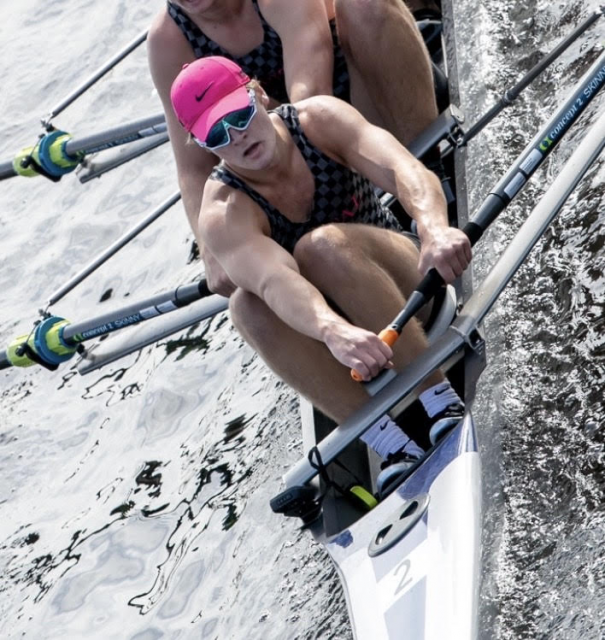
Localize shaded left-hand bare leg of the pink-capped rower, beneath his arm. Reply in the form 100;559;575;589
229;289;368;423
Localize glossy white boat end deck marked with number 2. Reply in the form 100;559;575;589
315;414;481;640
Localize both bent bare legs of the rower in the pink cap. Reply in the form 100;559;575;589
229;224;444;422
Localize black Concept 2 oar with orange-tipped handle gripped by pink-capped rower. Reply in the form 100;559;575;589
351;53;605;381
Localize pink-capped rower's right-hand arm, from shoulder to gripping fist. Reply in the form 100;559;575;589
299;96;471;282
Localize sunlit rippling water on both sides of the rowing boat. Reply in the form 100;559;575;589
0;0;605;640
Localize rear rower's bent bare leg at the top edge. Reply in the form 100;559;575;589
335;0;437;144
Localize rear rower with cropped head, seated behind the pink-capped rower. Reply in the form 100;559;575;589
148;0;437;296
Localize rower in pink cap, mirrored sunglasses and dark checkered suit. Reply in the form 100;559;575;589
171;57;471;496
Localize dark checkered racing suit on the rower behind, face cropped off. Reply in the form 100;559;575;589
168;0;349;102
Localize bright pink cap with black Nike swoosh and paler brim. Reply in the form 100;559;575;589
170;56;250;141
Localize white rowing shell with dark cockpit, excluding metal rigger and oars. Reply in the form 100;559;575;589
290;3;484;640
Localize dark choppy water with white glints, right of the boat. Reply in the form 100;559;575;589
462;2;605;640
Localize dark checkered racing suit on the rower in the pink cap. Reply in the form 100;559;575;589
209;104;407;253
